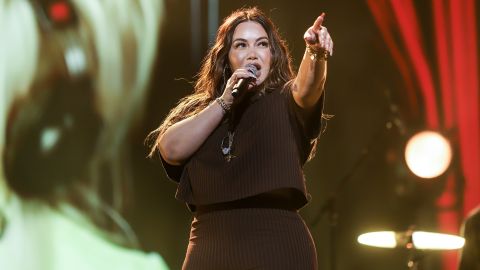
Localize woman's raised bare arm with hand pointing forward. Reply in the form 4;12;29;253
293;13;333;111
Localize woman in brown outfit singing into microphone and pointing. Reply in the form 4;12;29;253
151;8;333;270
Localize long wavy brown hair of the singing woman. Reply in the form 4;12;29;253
147;7;295;156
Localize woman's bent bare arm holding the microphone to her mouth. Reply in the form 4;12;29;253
158;68;252;165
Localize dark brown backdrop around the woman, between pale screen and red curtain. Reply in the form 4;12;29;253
127;0;456;270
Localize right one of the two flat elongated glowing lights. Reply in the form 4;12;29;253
412;231;465;250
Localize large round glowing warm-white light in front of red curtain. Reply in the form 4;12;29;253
405;131;452;178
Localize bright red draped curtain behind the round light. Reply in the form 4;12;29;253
367;0;480;270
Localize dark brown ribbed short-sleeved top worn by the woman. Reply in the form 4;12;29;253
162;86;323;209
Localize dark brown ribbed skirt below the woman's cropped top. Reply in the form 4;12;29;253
182;208;318;270
